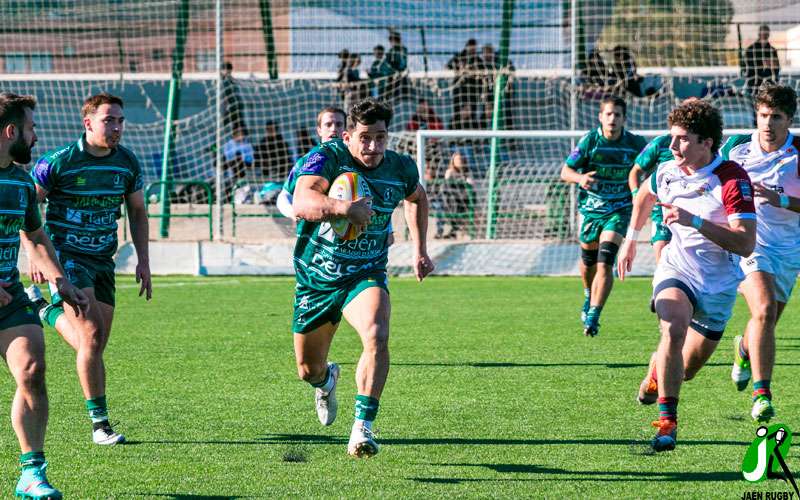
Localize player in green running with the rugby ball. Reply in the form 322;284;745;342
292;98;433;457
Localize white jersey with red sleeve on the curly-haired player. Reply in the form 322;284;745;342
650;156;756;294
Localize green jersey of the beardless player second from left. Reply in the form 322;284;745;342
31;136;143;257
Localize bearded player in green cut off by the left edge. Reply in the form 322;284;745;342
0;92;89;499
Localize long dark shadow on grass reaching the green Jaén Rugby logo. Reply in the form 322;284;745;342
407;462;742;484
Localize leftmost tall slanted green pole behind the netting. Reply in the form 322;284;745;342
160;0;189;238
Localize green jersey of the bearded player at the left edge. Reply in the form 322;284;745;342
0;163;42;284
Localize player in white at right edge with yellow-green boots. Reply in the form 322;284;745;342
720;84;800;422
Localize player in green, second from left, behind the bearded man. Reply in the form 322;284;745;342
23;93;152;445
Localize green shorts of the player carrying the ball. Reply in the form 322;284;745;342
292;272;389;333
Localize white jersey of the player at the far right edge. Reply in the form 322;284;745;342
728;132;800;256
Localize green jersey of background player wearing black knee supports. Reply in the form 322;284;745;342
565;127;647;216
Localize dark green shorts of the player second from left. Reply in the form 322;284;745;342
50;252;117;307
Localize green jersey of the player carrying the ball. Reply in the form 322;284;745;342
294;140;419;290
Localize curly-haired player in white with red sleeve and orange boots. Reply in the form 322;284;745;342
618;99;756;451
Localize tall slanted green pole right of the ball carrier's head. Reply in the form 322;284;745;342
486;0;514;240
